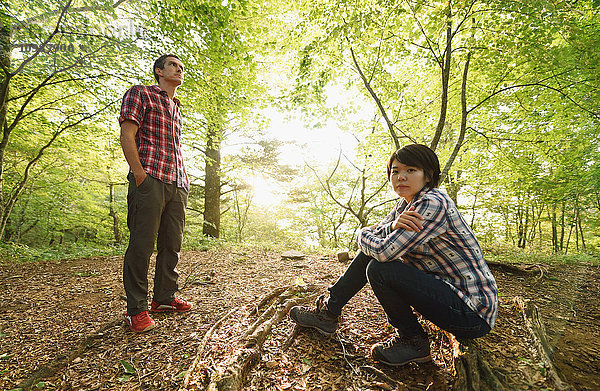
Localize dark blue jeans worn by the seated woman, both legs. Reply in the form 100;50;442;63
327;252;490;339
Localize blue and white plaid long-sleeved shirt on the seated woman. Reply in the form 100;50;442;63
358;188;498;328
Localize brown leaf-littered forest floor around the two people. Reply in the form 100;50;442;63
0;249;600;390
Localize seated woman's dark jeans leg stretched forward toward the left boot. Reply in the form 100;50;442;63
327;252;371;316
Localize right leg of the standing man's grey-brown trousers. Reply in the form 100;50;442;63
154;184;188;304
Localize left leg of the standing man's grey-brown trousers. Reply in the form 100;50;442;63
123;173;163;315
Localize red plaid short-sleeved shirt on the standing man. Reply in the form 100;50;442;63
119;85;189;189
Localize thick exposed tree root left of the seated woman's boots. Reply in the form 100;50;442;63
180;285;319;391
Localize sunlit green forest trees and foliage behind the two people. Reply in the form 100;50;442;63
0;0;600;254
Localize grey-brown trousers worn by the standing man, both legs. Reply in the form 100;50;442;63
123;173;187;315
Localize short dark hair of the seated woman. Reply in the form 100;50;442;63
387;144;440;187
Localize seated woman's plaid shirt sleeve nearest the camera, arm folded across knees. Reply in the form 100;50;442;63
357;198;447;262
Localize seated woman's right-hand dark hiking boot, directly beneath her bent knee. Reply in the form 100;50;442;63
371;335;431;366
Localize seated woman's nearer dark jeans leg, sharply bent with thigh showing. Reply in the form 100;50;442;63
367;260;490;339
